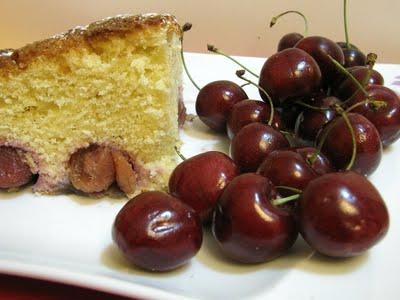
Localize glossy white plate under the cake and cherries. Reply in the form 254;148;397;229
0;54;400;300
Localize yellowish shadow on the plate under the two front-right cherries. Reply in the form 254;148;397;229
196;231;368;275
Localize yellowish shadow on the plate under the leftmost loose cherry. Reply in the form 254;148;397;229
100;244;190;278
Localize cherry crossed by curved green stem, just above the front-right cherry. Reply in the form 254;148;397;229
319;113;382;176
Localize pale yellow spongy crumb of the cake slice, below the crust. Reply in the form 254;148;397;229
0;18;182;193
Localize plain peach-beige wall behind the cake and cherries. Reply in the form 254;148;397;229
0;0;400;63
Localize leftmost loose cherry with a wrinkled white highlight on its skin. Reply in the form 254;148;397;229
112;192;203;271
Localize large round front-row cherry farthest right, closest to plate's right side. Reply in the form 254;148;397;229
298;172;389;257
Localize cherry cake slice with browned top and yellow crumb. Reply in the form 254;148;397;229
0;14;184;196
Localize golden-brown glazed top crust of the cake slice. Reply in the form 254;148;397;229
0;14;182;75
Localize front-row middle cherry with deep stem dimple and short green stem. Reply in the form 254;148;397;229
212;173;298;263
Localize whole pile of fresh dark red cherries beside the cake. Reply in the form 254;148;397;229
113;1;400;271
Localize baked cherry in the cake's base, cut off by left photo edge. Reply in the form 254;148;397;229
0;146;33;189
